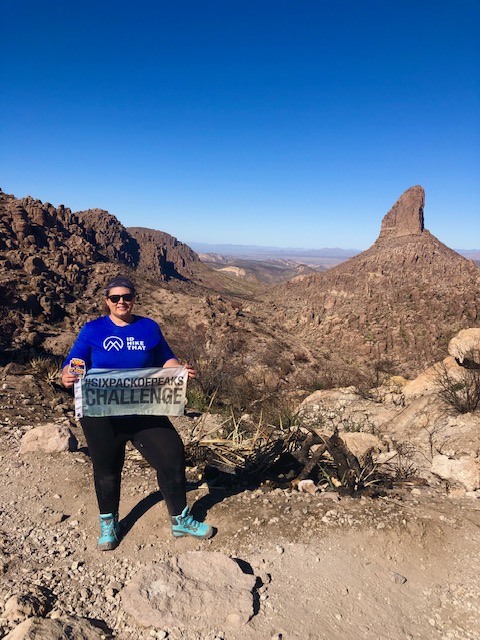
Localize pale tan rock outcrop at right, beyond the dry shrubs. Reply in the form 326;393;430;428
298;329;480;492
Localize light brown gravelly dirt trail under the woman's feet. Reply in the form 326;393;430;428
0;418;480;640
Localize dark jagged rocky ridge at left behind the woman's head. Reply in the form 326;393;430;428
0;191;221;362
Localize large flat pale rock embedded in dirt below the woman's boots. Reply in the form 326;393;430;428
121;551;256;629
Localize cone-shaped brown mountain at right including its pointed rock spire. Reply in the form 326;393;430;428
267;186;480;375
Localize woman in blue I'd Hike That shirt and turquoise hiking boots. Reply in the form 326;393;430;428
62;276;214;551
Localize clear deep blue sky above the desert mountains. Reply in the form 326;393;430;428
0;0;480;249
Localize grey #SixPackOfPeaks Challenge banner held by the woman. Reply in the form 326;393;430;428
75;367;188;418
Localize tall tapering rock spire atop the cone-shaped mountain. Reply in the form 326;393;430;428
379;185;425;245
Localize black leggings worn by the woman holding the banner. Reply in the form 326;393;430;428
80;416;187;516
